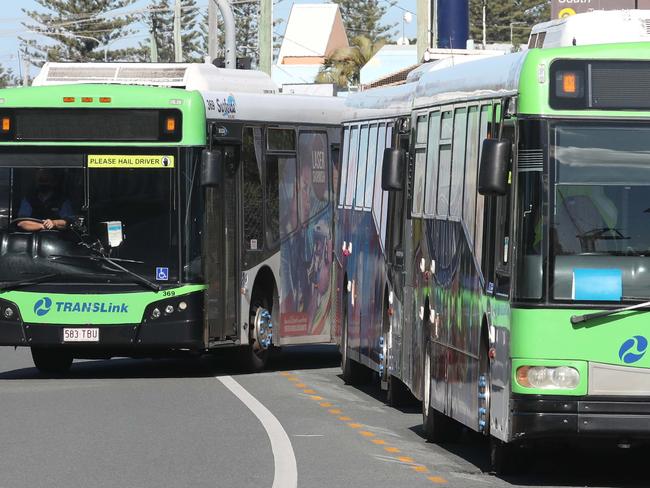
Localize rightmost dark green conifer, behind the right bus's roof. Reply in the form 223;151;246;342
469;0;551;45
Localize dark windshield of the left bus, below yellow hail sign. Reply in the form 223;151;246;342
0;150;179;284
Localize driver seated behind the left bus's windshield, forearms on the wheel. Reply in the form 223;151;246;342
17;169;73;232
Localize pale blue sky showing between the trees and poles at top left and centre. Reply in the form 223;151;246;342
0;0;417;74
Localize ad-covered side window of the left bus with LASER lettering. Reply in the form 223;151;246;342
298;132;329;223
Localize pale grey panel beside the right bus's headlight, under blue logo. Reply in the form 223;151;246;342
588;363;650;396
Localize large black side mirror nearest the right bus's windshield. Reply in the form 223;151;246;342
478;139;510;196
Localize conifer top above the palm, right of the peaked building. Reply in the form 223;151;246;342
334;0;397;44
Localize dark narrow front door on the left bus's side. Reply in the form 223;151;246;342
203;143;240;343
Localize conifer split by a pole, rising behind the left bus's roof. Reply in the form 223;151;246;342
139;0;203;63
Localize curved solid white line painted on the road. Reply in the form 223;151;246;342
217;376;298;488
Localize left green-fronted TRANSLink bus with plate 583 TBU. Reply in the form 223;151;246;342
0;64;342;372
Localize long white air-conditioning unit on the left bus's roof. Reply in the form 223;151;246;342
32;63;278;93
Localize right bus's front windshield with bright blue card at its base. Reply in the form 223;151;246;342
550;123;650;301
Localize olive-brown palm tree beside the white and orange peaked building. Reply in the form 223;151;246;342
316;36;385;88
